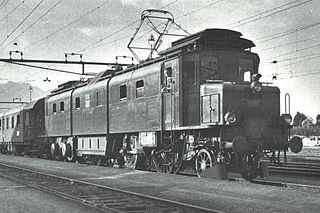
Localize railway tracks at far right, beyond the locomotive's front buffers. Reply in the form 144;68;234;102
268;162;320;177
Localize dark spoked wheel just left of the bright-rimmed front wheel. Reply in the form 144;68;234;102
152;151;175;174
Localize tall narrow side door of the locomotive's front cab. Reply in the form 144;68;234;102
161;59;179;130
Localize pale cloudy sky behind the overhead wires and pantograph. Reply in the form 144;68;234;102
0;0;320;118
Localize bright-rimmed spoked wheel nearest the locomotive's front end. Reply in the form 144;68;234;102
195;149;216;177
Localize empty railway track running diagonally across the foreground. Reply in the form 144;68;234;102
0;163;221;213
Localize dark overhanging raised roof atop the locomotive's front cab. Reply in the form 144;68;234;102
160;29;255;55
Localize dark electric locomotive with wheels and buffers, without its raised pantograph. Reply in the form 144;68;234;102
0;29;302;179
